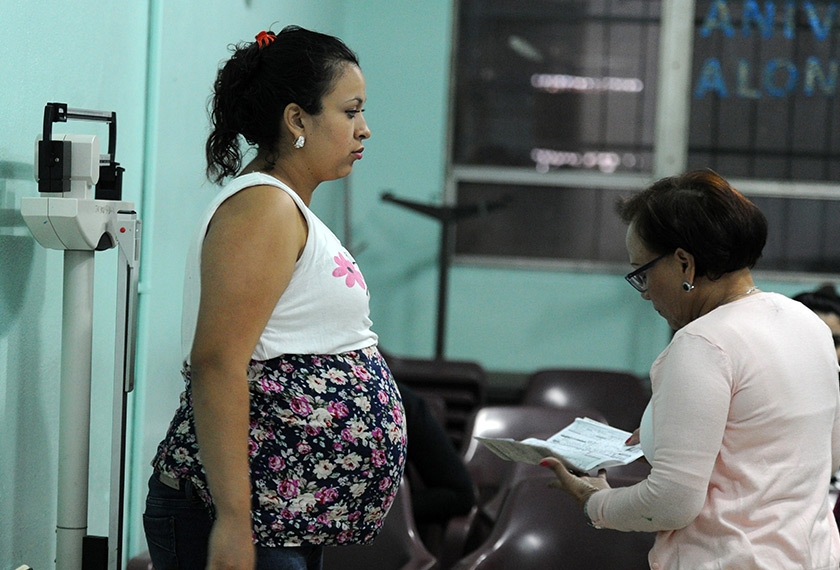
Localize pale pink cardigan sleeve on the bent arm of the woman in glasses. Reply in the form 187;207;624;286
587;333;732;531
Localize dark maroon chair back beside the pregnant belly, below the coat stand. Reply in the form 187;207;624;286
385;354;487;449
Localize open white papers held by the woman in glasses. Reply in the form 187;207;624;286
475;418;643;474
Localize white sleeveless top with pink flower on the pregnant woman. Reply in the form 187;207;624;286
181;172;378;362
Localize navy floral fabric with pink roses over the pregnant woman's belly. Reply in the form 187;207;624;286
152;346;406;546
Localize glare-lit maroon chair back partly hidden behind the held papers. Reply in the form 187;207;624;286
463;406;605;505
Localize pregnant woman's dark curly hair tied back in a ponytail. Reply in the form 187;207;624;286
205;26;359;183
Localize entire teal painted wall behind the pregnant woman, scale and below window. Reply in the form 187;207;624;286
0;0;828;560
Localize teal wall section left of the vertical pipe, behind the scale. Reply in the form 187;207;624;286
0;0;147;568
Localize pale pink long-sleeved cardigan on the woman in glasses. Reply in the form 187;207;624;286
587;293;840;570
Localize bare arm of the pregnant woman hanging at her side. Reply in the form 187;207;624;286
190;186;306;570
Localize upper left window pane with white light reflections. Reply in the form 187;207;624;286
452;0;660;173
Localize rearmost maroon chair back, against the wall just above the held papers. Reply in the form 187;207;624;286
522;368;650;432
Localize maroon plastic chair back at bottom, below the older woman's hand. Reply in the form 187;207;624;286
453;476;655;570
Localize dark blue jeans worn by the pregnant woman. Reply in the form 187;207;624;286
143;474;324;570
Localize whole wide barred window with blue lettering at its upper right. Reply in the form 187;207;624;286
447;0;840;274
